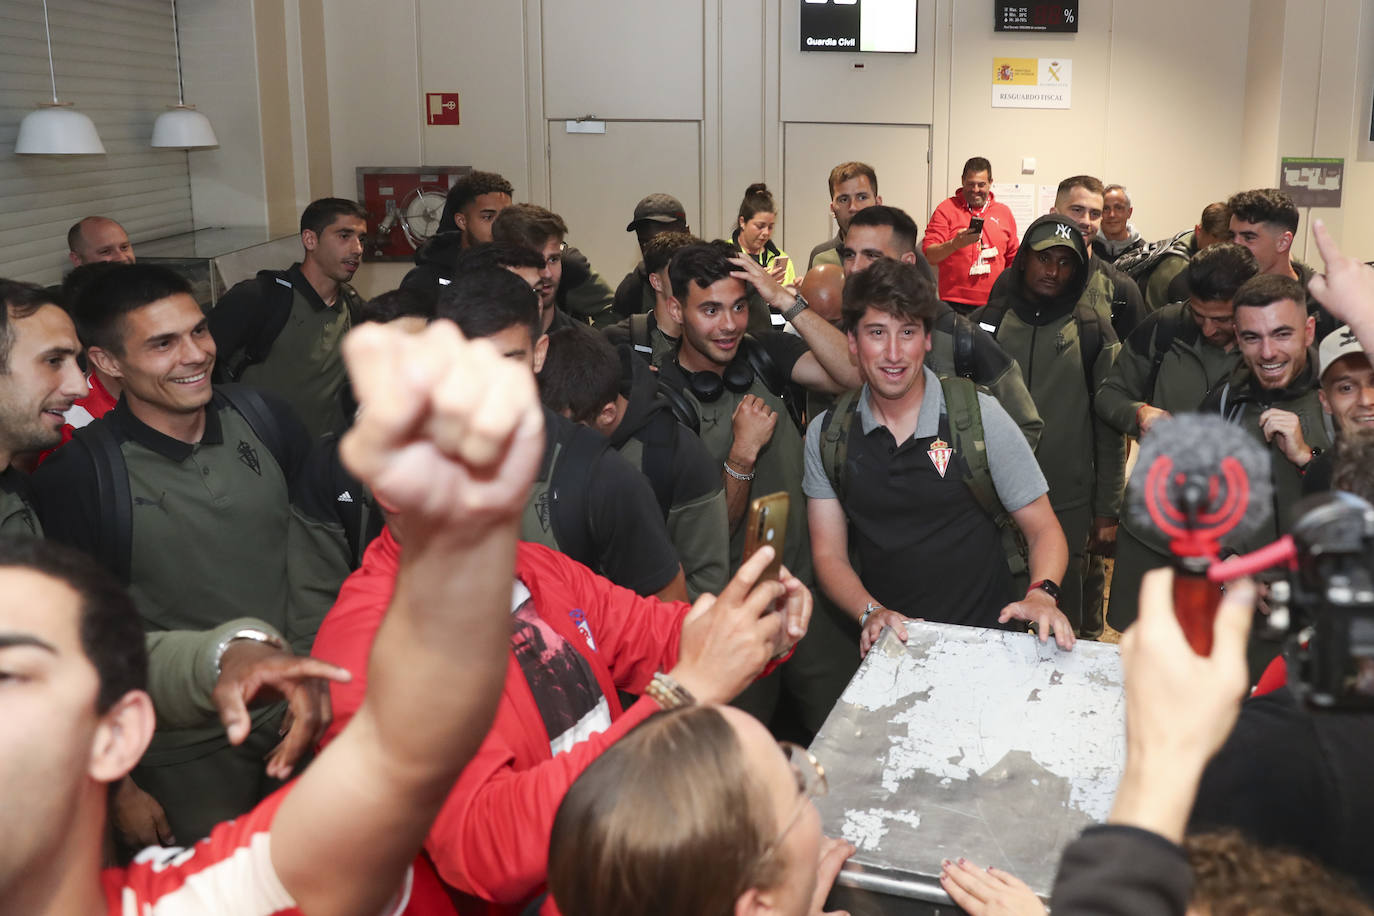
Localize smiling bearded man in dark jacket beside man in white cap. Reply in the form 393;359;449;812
1201;273;1331;548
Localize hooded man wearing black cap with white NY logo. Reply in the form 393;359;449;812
974;214;1125;629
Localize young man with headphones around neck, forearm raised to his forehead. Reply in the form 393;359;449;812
660;243;860;732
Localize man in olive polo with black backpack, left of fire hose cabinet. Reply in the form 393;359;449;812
209;198;367;438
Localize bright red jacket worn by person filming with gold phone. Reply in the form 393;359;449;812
313;531;690;913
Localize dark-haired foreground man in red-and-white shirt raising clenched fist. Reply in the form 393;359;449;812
0;311;563;916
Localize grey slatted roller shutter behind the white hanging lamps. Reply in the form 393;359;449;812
0;0;192;283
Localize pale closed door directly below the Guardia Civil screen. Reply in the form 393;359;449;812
782;121;944;265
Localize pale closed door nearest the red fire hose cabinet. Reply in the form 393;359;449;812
548;121;709;281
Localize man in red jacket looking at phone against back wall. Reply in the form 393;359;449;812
921;157;1021;314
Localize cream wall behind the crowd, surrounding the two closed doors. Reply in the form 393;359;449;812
185;0;1374;298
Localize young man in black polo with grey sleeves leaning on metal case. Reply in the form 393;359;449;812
802;260;1074;652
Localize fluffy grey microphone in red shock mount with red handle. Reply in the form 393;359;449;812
1127;413;1274;655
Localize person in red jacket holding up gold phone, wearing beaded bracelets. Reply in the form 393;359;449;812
313;518;811;913
